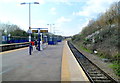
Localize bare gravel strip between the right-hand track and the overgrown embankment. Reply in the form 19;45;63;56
74;45;120;82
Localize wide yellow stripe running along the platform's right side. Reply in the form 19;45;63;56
61;42;71;83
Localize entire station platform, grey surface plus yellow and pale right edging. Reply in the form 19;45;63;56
0;41;89;83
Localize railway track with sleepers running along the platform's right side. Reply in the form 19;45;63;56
68;41;117;83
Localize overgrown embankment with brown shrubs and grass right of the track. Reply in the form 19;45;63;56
72;2;120;77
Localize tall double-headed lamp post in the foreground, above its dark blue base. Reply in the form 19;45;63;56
21;2;39;42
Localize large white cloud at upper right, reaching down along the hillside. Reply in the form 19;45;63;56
72;0;118;31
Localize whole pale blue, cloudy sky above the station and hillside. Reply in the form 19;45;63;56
0;0;119;36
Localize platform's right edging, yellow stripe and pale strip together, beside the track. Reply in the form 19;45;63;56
61;41;89;83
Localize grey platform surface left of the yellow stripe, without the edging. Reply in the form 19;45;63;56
1;42;63;81
